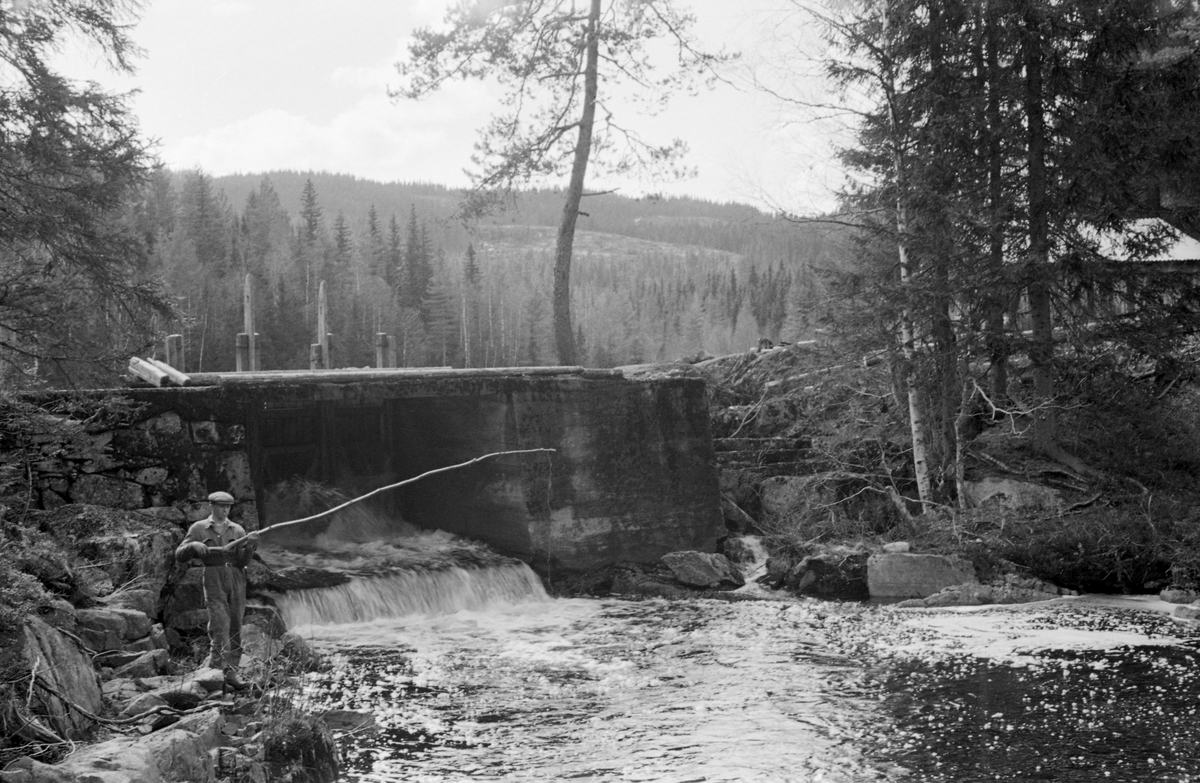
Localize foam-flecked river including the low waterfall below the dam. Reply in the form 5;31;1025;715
270;547;1200;783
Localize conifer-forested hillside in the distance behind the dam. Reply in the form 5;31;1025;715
134;171;845;371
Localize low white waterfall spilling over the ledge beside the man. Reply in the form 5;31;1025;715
278;563;550;628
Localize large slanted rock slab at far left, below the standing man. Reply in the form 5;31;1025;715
18;617;102;740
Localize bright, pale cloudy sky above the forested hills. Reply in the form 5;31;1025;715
56;0;840;213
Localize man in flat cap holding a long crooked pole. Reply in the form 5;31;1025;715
175;492;258;691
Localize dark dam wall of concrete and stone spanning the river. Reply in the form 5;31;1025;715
18;367;725;574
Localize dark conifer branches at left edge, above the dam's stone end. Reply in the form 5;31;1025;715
0;0;168;385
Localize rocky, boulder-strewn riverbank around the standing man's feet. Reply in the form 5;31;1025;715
0;506;337;783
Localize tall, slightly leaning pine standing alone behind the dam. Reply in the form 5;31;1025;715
392;0;728;364
